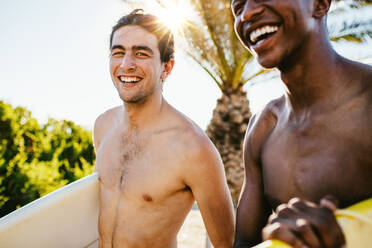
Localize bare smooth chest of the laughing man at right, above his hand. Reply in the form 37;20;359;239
261;109;372;206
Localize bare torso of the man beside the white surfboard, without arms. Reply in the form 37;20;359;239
96;109;194;247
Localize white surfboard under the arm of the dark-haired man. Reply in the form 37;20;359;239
0;173;99;248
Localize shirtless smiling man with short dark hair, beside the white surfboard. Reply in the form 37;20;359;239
94;10;234;248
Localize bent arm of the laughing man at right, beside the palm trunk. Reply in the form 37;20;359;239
234;111;275;247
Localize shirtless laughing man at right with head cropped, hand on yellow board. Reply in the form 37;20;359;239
231;0;372;247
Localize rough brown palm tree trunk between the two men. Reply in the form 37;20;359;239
206;85;251;204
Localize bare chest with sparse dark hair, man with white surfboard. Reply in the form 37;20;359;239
96;130;185;204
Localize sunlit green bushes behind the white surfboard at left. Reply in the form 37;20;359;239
0;101;95;216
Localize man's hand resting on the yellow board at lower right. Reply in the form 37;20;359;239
262;197;345;248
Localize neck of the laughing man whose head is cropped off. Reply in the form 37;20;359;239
279;31;344;115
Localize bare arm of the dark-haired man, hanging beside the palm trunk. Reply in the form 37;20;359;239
185;137;234;248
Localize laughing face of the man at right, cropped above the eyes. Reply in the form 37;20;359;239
231;0;314;68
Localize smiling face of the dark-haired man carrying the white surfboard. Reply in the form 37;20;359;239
110;25;163;103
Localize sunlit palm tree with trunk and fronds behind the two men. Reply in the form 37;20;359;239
124;0;372;203
